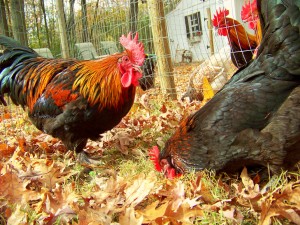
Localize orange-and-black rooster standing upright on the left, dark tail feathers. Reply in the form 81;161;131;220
0;33;145;163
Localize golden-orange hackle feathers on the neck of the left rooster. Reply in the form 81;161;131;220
70;53;135;109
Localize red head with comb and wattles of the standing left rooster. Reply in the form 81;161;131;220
118;33;145;87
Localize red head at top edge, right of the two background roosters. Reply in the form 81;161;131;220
241;0;259;30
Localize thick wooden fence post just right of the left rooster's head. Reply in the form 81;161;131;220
147;0;177;100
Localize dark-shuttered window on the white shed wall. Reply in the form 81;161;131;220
185;12;202;41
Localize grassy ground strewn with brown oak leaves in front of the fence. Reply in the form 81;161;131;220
0;63;300;225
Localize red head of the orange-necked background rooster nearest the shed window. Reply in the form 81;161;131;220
212;9;231;36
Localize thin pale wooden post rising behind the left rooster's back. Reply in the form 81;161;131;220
56;0;70;58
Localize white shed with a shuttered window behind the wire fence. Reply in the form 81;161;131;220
166;0;251;62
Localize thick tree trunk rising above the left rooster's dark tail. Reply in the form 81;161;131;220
10;0;28;46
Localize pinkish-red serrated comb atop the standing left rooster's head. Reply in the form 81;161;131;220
120;32;145;66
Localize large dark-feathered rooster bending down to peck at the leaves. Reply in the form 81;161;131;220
149;1;300;178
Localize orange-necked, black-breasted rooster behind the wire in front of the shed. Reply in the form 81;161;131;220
212;9;258;68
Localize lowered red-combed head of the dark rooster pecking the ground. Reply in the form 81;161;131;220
149;146;184;179
